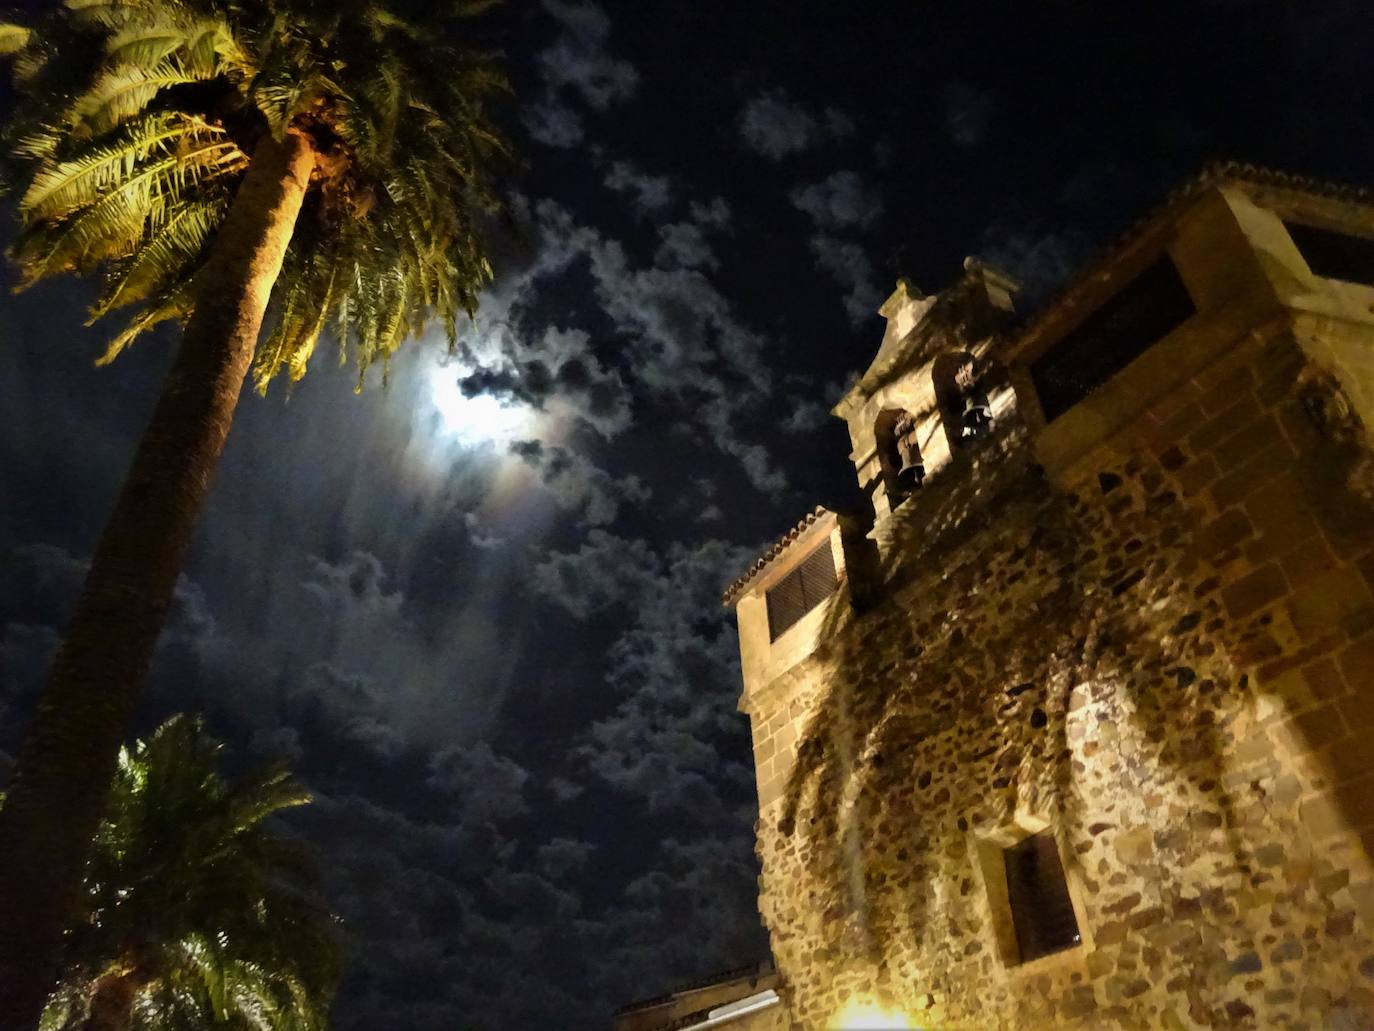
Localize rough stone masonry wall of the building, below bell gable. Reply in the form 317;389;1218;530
746;305;1374;1031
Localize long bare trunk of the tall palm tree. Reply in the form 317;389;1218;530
0;133;315;1031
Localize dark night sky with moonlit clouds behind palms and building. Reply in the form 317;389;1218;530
0;0;1374;1031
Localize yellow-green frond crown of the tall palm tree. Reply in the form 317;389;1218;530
0;0;504;390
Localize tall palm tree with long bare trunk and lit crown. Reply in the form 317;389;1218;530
0;0;503;1031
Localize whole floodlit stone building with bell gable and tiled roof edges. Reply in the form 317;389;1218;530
725;166;1374;1031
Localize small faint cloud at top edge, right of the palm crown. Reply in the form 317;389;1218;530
525;0;639;147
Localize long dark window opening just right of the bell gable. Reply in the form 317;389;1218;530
1031;254;1197;419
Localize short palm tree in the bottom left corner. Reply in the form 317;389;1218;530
30;716;338;1031
